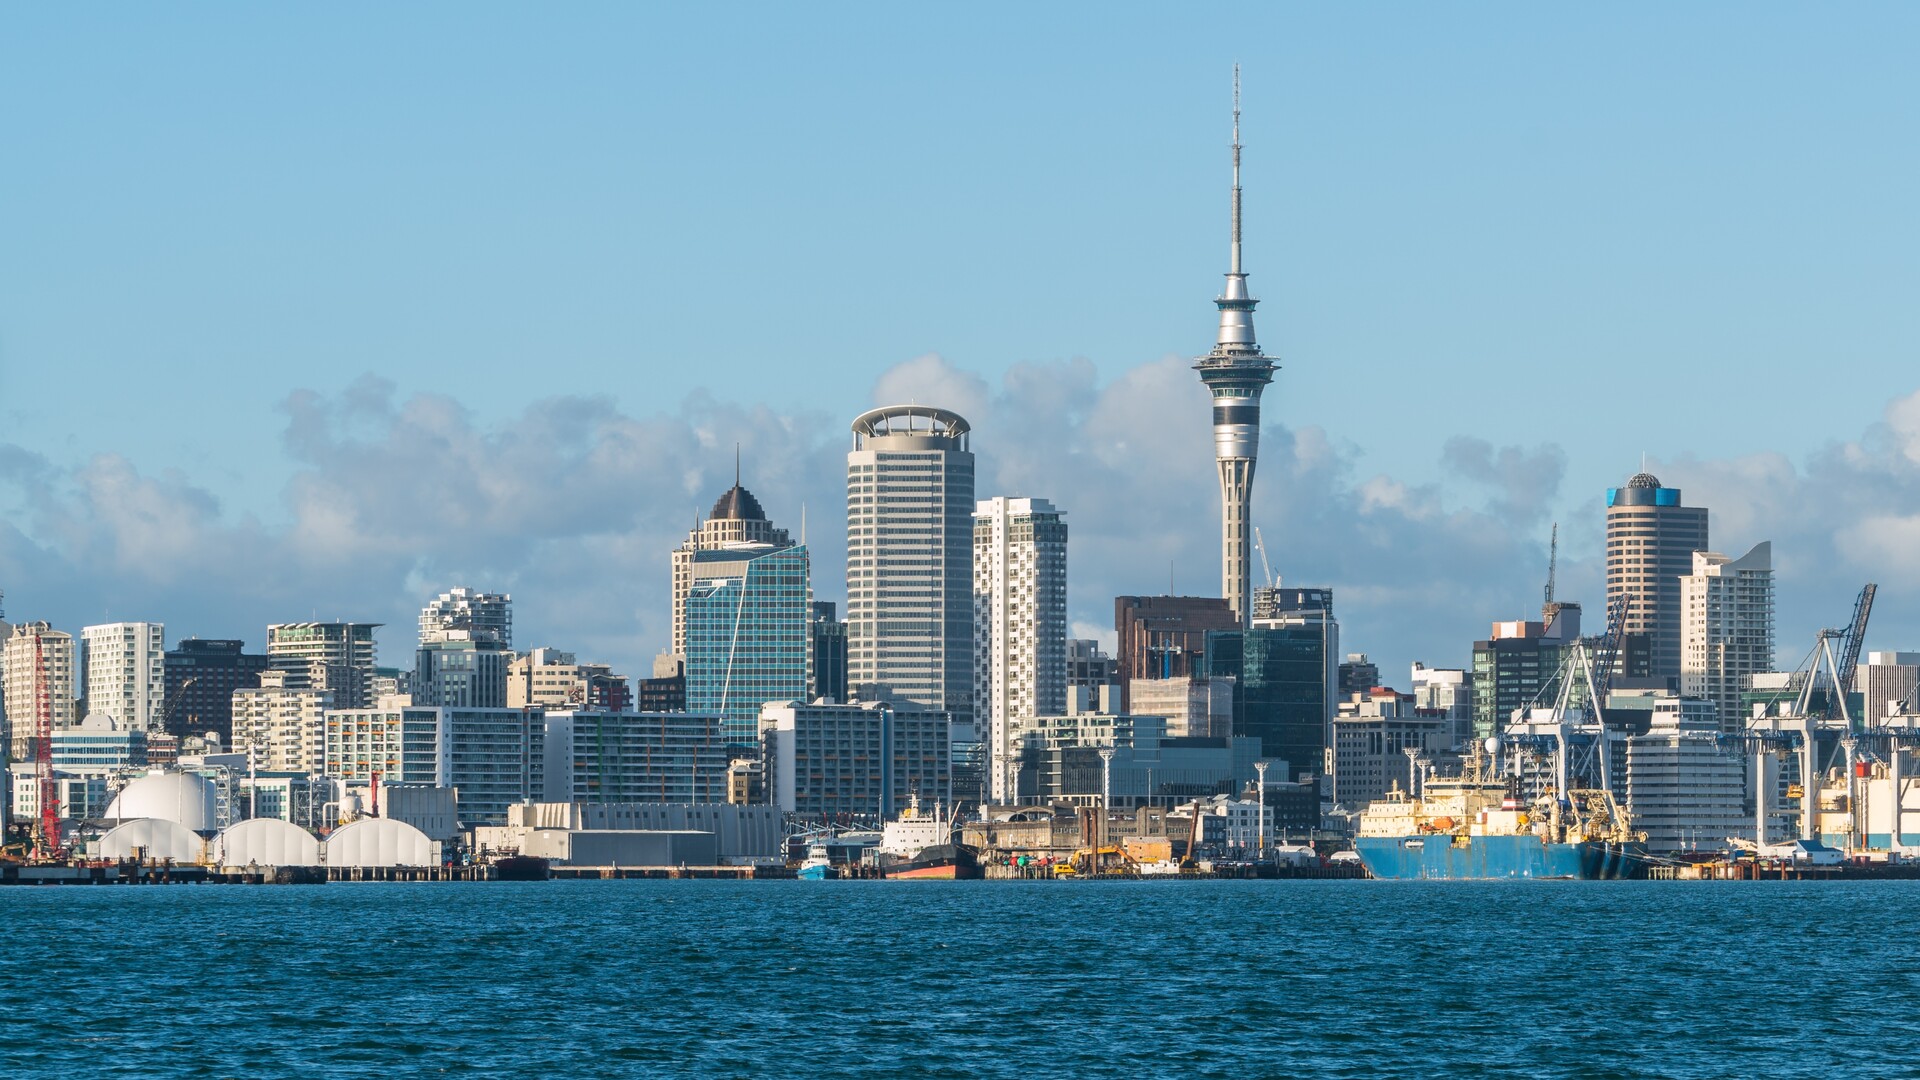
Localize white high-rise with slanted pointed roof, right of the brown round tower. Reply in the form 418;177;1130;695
1680;540;1774;732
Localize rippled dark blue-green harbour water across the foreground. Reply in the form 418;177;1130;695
0;880;1920;1080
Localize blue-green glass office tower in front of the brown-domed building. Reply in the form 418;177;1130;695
687;544;814;748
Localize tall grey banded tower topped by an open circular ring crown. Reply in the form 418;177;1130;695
847;405;973;726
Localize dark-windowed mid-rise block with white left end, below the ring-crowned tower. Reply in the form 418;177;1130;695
760;701;952;821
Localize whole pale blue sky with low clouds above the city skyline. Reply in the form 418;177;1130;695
0;4;1920;684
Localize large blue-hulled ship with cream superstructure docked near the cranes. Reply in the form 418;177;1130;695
1354;748;1647;880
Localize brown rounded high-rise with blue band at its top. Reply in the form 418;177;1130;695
1607;473;1707;680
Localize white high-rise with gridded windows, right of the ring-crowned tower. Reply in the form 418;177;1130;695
973;498;1068;803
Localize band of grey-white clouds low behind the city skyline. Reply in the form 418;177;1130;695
0;356;1920;682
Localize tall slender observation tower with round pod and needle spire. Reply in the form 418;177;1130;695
1194;63;1279;626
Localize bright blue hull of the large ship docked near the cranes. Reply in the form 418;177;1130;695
1354;834;1647;880
